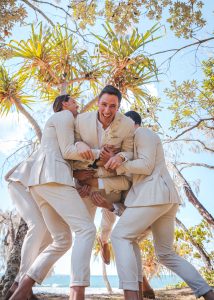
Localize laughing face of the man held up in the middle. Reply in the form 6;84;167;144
98;93;119;129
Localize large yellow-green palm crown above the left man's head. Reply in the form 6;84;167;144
9;23;102;95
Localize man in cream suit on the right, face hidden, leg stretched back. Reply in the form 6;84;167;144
109;111;214;300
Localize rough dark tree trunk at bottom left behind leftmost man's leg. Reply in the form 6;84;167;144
0;219;27;296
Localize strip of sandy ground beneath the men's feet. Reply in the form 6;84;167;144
37;288;203;300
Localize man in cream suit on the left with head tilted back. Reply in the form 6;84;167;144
11;95;96;300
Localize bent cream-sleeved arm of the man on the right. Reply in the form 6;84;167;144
117;129;158;175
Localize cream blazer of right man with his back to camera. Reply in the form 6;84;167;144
117;128;181;207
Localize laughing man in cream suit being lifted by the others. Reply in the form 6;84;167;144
73;85;134;263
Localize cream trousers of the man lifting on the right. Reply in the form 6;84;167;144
111;204;211;297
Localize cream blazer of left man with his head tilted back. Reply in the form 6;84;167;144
28;110;87;186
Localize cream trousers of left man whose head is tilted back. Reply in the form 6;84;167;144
27;183;96;286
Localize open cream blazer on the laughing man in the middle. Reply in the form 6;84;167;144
74;111;134;172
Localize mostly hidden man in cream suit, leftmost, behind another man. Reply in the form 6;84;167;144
4;153;52;300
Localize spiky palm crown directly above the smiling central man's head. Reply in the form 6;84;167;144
82;23;160;109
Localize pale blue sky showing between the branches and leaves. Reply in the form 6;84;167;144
0;0;214;274
